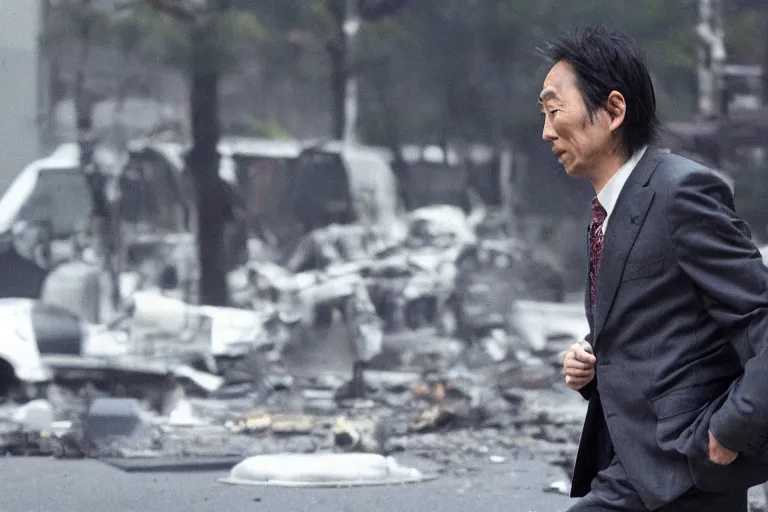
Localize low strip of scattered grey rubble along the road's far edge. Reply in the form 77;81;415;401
0;352;585;474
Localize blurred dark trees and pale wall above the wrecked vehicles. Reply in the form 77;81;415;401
0;0;768;299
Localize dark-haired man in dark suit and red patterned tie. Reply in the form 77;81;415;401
539;28;768;512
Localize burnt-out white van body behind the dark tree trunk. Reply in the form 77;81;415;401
122;137;402;268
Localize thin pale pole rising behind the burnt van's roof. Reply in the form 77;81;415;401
343;0;362;146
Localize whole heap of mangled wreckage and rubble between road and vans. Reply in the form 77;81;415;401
0;195;586;484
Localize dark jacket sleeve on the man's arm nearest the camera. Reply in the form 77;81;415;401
667;171;768;453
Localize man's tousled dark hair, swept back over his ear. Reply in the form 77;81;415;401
542;27;659;156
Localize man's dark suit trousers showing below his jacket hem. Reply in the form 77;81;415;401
568;456;748;512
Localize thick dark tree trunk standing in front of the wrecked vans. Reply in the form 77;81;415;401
146;0;260;305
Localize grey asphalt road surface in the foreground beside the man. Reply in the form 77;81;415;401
0;457;571;512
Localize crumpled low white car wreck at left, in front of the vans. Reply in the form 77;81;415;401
0;291;298;408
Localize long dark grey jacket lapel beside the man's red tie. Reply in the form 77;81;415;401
593;149;662;343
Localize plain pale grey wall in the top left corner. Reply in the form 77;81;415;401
0;0;41;194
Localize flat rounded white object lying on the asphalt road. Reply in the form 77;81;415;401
220;453;434;487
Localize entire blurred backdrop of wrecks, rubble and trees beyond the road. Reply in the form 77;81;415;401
0;0;768;492
